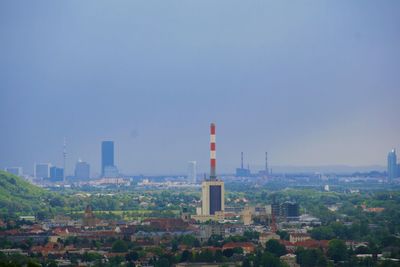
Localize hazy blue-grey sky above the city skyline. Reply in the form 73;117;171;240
0;0;400;174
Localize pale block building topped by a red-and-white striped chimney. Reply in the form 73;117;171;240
201;123;225;216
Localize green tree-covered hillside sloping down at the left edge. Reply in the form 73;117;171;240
0;171;59;216
